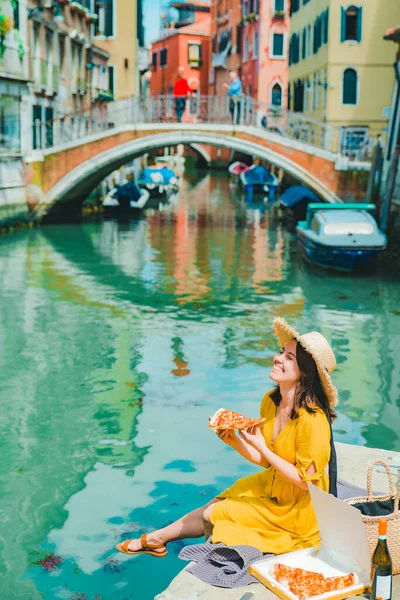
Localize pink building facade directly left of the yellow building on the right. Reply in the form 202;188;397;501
240;0;289;108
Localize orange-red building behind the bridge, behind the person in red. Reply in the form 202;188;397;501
150;2;211;95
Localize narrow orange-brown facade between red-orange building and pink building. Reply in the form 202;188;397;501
209;0;242;96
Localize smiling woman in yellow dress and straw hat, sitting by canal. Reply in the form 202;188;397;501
117;318;337;557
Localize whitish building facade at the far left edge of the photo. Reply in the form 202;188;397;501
0;0;29;222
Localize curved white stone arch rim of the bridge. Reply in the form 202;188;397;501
38;129;338;216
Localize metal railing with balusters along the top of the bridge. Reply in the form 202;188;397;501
34;95;374;161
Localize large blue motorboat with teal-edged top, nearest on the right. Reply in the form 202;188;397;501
296;203;387;272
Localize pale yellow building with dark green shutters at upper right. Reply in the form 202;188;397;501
289;0;400;147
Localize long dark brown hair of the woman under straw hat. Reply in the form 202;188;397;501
271;343;336;423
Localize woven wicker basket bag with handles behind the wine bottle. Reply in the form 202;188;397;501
344;459;400;575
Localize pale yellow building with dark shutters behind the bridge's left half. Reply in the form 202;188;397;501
95;0;143;100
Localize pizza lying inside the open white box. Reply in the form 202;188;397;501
274;563;358;600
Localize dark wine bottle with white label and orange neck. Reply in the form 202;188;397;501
370;519;393;600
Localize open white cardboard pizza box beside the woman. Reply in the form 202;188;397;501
249;484;371;600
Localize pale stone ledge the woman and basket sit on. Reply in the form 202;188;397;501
155;443;400;600
